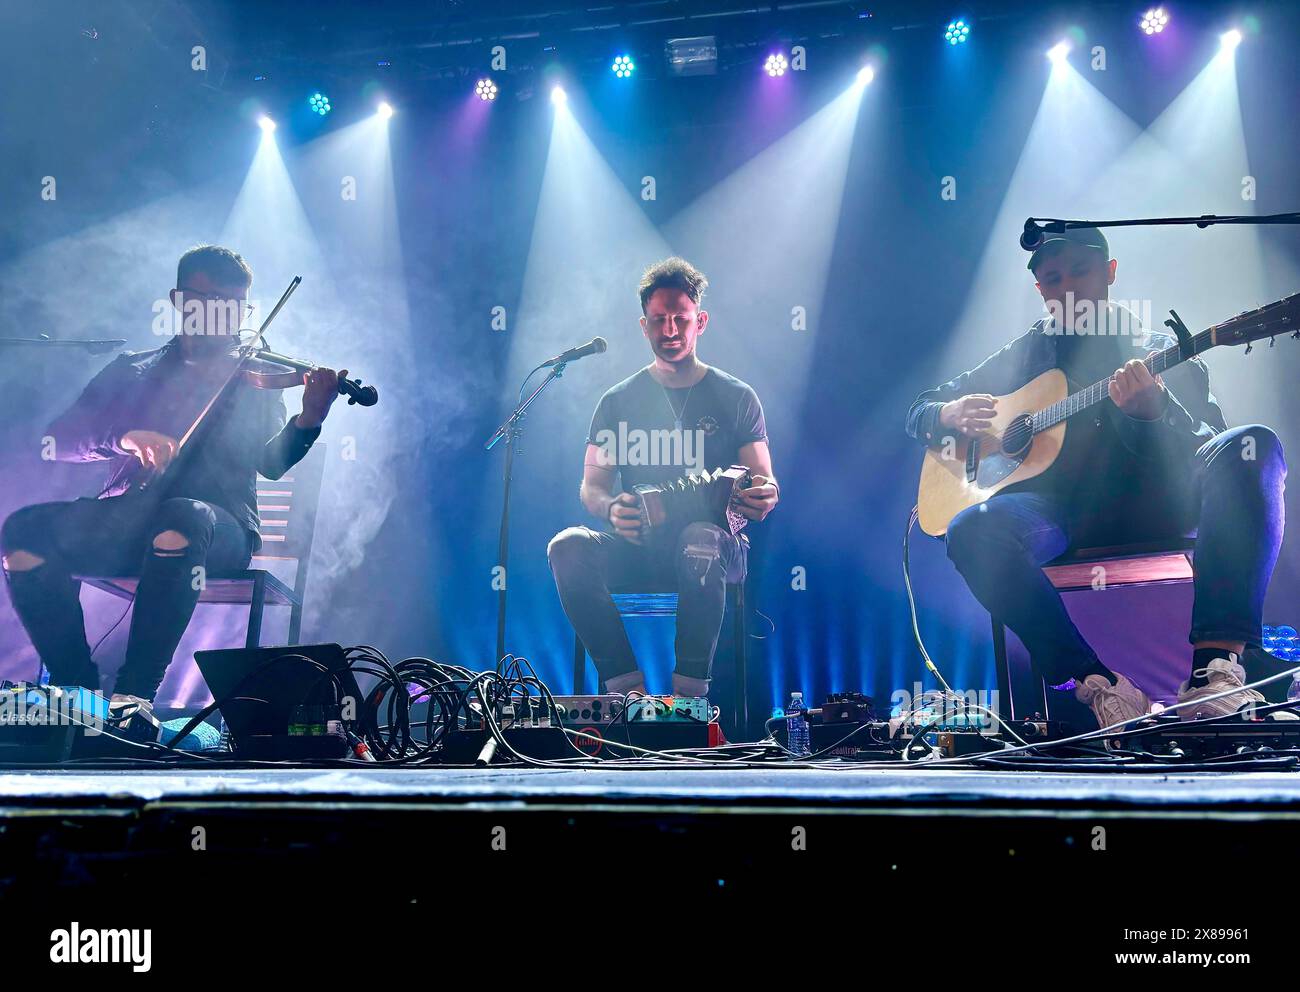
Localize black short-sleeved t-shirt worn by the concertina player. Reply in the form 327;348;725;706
586;367;767;491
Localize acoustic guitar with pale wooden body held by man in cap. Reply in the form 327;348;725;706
917;293;1300;537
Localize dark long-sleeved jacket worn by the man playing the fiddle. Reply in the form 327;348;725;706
47;341;320;545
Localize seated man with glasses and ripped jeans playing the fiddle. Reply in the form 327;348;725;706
0;244;347;709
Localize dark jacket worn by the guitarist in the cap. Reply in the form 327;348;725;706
906;308;1227;527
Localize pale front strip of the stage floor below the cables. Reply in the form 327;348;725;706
0;766;1300;816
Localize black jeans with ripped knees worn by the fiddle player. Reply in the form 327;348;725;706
0;497;255;699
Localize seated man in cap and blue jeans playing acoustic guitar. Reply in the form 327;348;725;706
907;228;1291;727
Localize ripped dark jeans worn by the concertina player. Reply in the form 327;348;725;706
546;523;748;681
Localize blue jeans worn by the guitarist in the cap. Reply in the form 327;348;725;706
948;425;1287;685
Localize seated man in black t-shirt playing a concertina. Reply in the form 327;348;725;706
546;257;780;696
